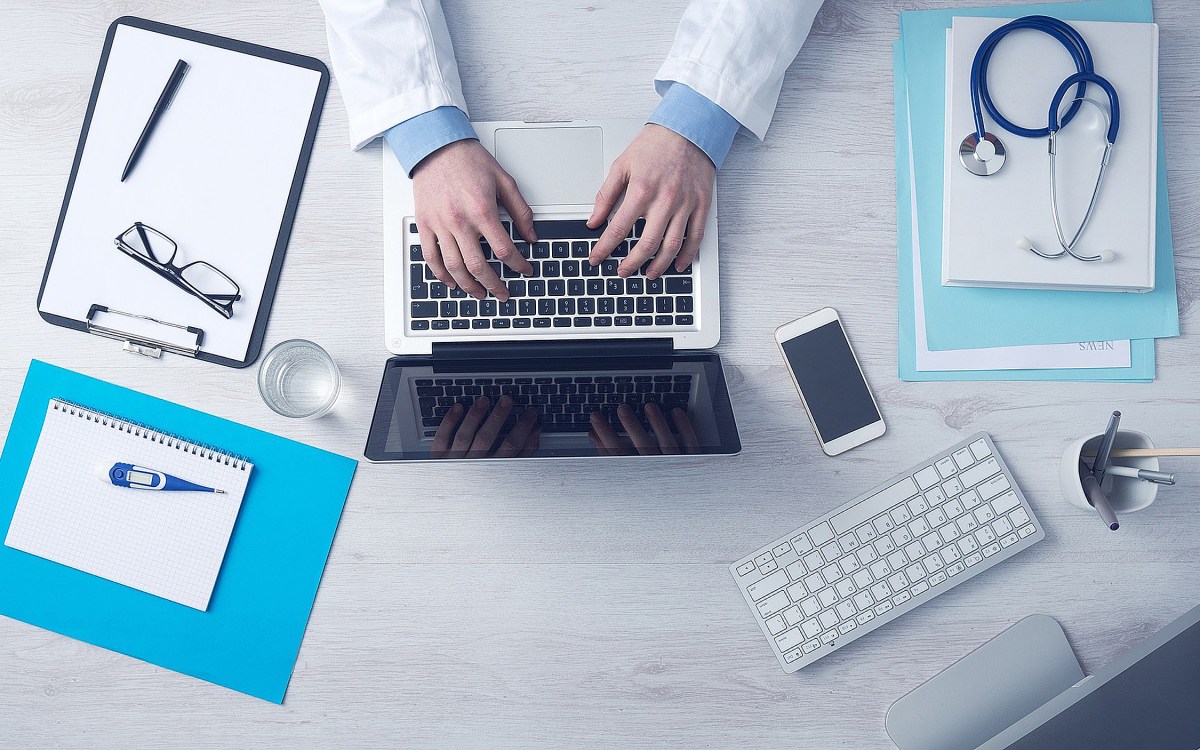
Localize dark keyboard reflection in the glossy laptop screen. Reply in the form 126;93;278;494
414;373;692;438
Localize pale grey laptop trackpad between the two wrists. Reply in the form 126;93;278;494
496;127;604;205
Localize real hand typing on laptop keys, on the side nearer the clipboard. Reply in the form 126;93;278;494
413;140;538;302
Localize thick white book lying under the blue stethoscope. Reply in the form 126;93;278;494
942;17;1158;292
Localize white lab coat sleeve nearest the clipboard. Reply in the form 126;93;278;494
320;0;467;149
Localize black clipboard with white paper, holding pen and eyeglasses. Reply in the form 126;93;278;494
37;17;329;367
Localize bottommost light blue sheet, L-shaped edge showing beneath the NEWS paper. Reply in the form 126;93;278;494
892;41;1154;383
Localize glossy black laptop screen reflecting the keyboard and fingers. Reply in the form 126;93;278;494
365;353;742;461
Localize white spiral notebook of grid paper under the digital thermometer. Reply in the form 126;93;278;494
5;398;253;611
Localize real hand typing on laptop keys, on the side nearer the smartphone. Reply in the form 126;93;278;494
588;124;716;278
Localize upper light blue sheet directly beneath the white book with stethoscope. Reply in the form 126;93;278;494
900;0;1180;350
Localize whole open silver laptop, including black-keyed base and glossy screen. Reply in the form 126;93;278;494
365;120;740;461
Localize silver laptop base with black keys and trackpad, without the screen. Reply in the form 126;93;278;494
384;120;721;354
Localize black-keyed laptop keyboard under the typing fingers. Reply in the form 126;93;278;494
406;220;696;331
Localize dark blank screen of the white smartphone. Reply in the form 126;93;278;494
780;320;882;443
